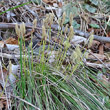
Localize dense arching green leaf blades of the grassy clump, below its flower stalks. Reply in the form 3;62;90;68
11;63;107;110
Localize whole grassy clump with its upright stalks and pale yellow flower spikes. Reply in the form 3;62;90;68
12;14;110;110
